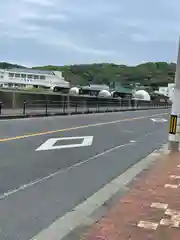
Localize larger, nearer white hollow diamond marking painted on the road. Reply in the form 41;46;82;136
36;136;93;151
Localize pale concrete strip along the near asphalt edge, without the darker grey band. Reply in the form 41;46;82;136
31;144;169;240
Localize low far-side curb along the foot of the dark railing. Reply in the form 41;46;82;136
0;107;169;120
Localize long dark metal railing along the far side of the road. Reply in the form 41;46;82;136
0;99;170;117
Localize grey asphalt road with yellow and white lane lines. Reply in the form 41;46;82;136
0;109;168;240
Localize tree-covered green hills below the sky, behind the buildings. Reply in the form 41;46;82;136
0;62;176;88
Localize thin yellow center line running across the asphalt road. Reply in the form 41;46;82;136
0;113;168;142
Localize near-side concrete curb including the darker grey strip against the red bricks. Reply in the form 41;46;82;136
31;144;169;240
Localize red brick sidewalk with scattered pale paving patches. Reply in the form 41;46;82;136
81;153;180;240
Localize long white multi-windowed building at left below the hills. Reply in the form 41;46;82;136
0;68;70;88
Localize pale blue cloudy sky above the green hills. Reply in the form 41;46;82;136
0;0;180;66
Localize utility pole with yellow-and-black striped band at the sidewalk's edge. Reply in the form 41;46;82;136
169;39;180;152
